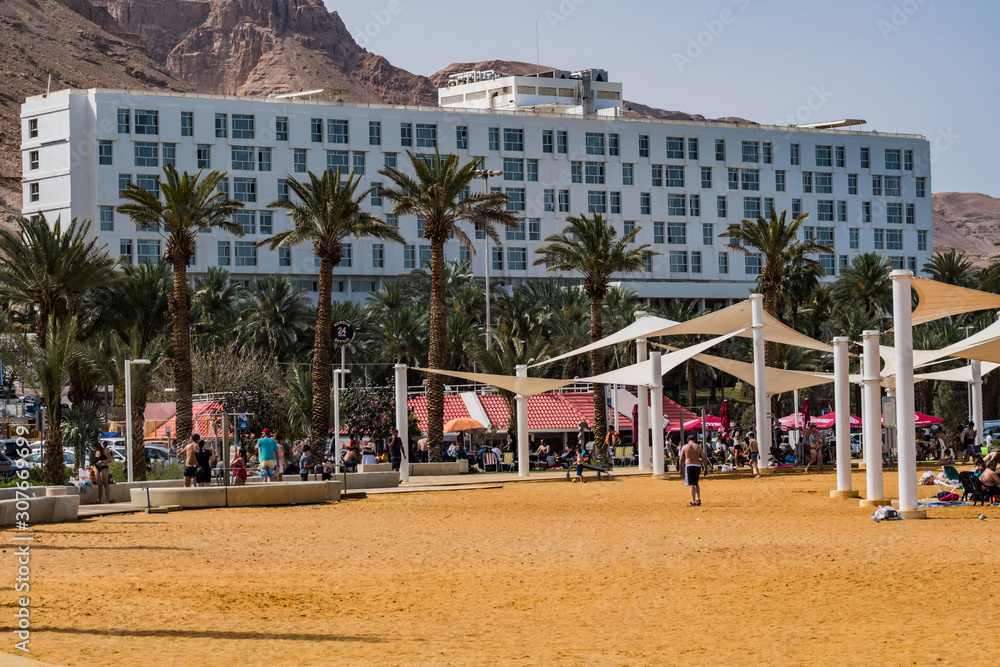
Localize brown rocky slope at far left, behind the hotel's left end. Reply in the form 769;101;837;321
0;0;191;226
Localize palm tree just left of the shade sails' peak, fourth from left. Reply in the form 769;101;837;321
535;213;660;462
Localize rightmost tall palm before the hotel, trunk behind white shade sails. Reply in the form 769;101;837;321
719;209;833;366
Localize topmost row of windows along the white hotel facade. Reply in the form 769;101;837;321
92;109;914;171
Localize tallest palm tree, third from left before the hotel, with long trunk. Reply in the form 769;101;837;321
380;150;519;461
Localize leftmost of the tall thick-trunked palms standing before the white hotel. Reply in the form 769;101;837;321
118;165;243;442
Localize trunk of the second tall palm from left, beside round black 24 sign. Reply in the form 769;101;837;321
309;257;340;465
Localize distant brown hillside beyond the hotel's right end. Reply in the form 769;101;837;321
931;192;1000;268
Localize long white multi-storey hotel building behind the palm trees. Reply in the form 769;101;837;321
21;70;932;300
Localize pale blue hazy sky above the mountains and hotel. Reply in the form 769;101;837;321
325;0;1000;196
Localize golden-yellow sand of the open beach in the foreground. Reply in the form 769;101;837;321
0;472;1000;665
